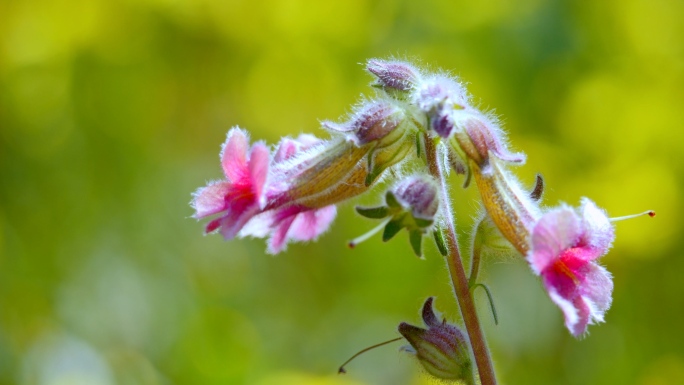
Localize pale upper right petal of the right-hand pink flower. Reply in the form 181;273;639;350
580;198;615;252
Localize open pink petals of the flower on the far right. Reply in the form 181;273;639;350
527;198;615;337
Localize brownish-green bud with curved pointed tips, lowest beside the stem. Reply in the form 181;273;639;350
399;297;474;384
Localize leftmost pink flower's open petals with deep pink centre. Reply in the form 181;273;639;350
190;127;270;239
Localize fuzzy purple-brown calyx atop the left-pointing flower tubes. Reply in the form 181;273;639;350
323;100;406;146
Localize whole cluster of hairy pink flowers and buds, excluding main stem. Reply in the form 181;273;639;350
191;59;648;378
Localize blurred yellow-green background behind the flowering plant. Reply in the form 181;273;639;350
0;0;684;385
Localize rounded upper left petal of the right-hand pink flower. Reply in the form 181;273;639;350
527;206;580;274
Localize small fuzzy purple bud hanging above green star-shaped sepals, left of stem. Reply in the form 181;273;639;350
392;174;439;220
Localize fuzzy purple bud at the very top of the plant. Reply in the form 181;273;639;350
366;59;420;94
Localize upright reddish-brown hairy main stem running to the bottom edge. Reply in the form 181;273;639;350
425;134;496;385
